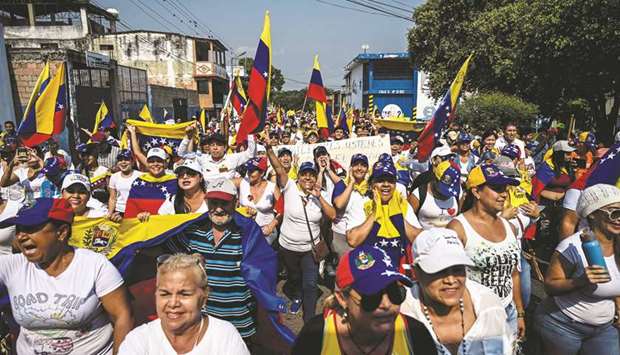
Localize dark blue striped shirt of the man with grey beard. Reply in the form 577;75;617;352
168;222;256;338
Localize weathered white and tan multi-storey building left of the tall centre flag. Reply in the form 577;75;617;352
92;31;228;120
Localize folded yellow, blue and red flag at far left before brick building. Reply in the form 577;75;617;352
17;63;67;147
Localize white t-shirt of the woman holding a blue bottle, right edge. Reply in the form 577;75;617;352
553;231;620;325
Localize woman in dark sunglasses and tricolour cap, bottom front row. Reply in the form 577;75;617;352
292;245;437;355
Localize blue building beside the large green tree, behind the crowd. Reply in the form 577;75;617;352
342;52;418;117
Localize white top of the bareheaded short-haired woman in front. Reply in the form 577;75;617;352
118;316;250;355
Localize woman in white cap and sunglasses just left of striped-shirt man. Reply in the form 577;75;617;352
158;157;208;215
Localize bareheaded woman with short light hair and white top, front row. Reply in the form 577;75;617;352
119;254;249;355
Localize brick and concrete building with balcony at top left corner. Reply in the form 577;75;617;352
0;0;148;144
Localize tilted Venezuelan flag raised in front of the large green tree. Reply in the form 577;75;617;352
416;53;473;161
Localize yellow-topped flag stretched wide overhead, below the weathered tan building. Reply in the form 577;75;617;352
121;120;194;154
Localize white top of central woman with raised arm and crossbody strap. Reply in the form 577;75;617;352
280;179;323;252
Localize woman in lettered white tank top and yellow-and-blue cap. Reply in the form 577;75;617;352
448;164;525;346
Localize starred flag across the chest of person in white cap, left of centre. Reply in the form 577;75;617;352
125;174;178;218
